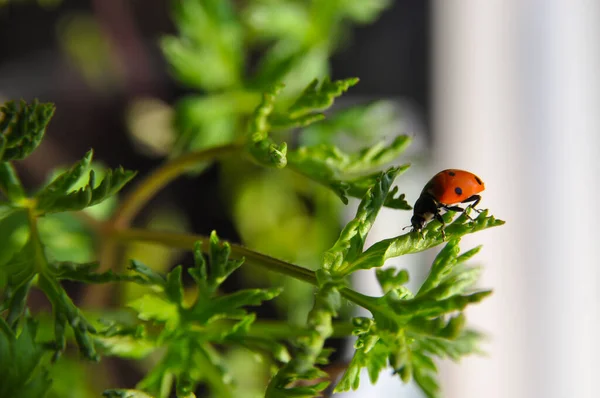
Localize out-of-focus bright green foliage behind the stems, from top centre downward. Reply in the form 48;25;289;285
161;0;399;332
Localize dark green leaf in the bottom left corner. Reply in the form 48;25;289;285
0;317;51;398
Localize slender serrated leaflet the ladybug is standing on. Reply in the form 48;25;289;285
348;210;504;272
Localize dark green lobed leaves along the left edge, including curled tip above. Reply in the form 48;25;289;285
0;102;135;360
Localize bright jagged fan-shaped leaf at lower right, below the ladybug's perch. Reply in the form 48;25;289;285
336;239;491;398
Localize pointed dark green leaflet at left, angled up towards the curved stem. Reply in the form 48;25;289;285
35;151;136;214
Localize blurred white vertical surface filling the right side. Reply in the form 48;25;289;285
432;0;600;398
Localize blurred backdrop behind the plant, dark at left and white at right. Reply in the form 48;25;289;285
0;0;600;398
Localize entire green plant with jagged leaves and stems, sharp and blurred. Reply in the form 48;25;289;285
0;0;503;397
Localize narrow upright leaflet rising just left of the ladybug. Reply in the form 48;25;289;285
323;168;401;276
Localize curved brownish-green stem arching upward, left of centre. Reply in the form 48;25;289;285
112;144;241;227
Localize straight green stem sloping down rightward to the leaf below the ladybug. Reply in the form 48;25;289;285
110;228;374;309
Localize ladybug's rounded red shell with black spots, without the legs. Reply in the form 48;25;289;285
423;169;485;205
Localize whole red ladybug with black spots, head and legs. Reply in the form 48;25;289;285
410;169;485;240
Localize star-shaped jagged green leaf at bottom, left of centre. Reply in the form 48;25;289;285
101;232;289;397
